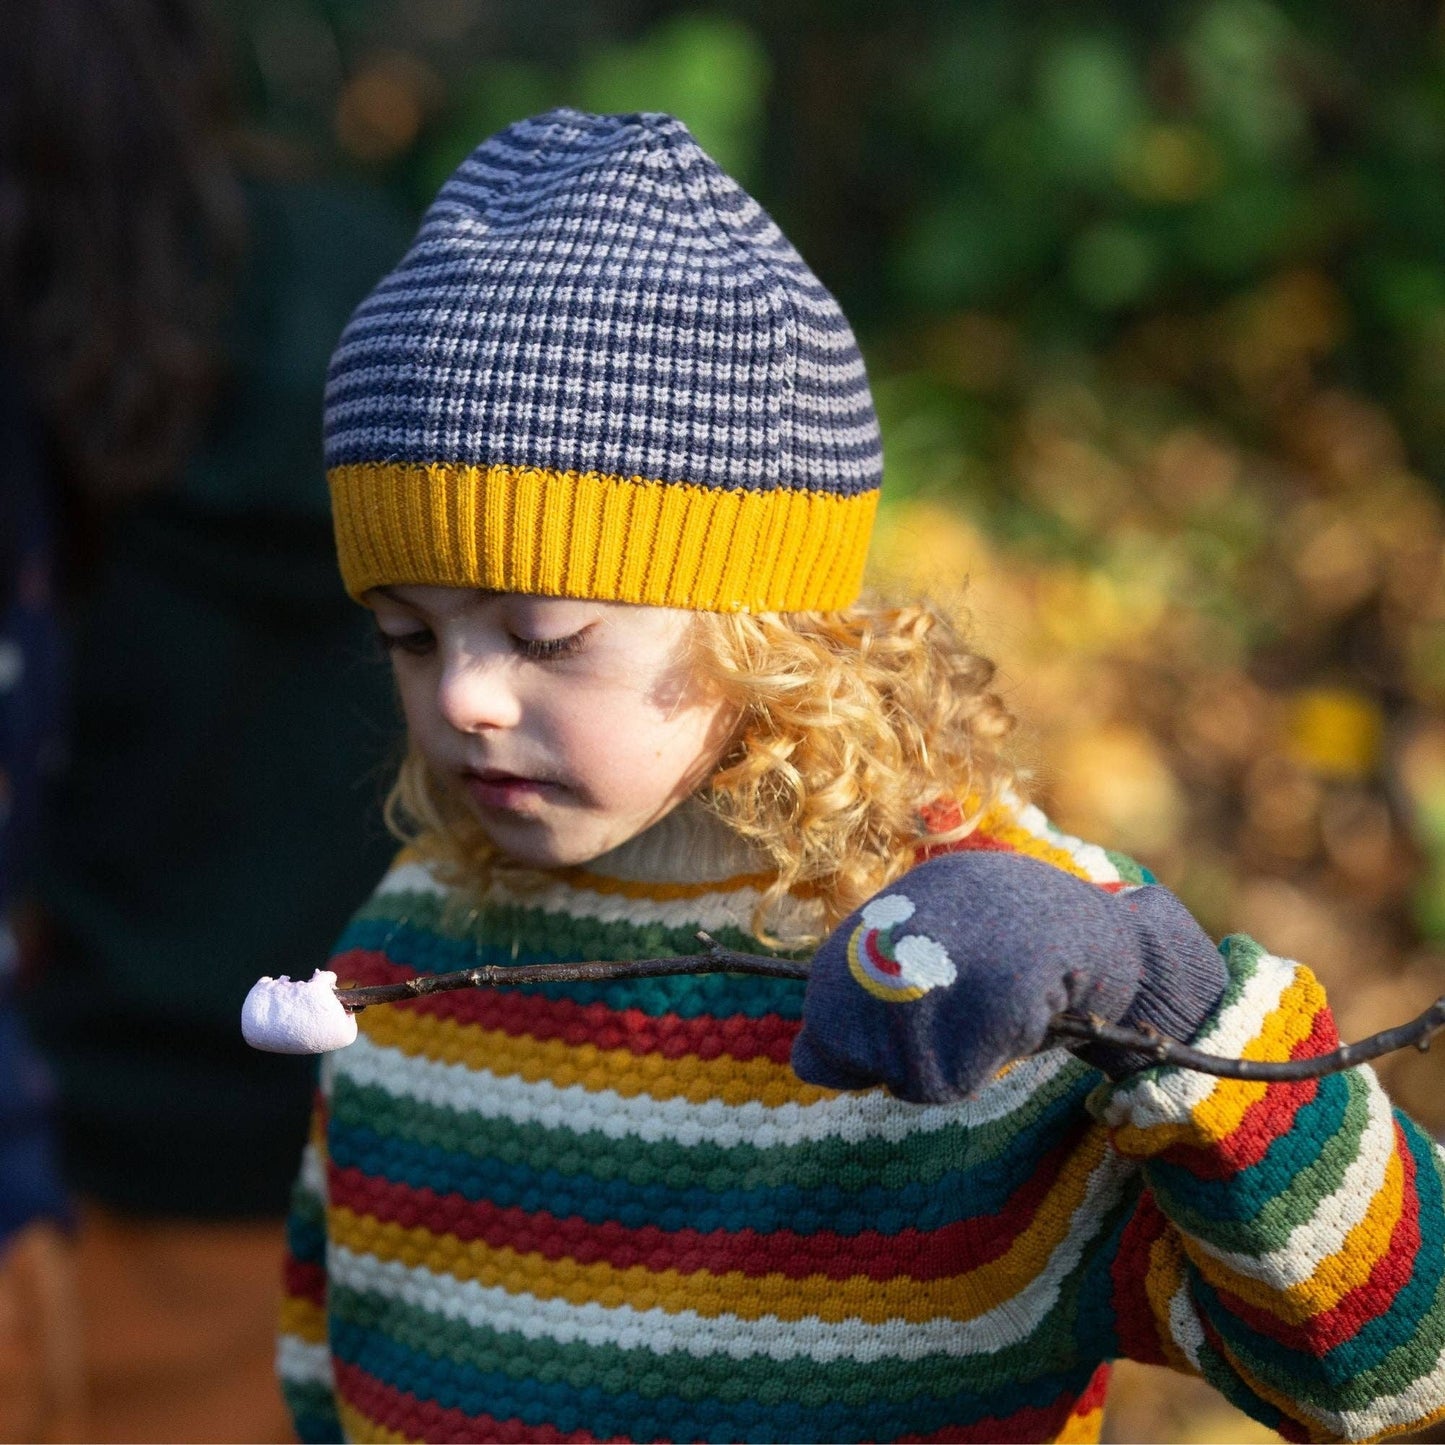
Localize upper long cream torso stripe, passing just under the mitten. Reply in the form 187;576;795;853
332;1035;1072;1149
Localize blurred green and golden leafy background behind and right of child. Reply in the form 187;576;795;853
225;0;1445;1129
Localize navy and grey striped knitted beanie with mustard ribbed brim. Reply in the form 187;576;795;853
325;110;883;611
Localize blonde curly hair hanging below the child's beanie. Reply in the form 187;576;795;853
386;601;1016;948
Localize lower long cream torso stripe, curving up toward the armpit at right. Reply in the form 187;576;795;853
331;1150;1130;1363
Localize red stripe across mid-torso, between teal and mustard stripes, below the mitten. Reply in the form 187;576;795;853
329;1140;1074;1280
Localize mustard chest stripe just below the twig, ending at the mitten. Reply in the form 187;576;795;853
357;1009;835;1108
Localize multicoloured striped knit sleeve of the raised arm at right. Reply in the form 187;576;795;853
1090;936;1445;1439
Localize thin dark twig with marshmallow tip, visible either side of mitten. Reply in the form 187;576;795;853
337;933;1445;1082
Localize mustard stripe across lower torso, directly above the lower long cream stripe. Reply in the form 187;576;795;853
328;1129;1107;1325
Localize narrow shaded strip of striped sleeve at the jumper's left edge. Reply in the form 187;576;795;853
276;1075;344;1441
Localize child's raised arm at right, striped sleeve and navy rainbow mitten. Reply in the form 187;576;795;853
793;853;1445;1438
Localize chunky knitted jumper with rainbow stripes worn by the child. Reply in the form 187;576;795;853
279;805;1445;1441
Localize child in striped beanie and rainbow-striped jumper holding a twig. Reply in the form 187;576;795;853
279;111;1445;1441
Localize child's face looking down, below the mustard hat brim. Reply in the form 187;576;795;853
367;587;731;867
